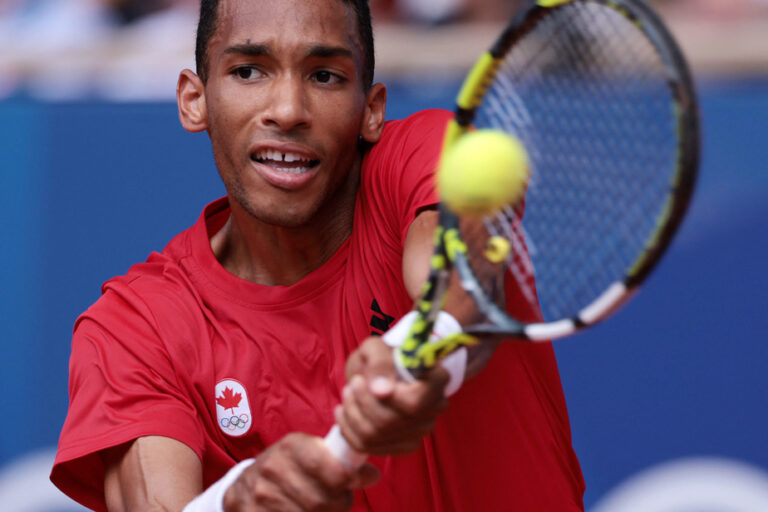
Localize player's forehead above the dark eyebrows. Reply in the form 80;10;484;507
210;0;362;53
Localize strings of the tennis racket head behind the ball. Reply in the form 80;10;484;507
468;1;677;320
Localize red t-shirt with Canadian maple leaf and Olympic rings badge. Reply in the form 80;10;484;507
51;111;584;512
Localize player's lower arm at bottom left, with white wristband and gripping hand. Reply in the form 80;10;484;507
102;433;379;512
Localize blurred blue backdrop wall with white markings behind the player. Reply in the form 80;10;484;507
0;2;768;512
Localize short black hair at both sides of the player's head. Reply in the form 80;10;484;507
195;0;376;89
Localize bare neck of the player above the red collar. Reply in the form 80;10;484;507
211;162;359;286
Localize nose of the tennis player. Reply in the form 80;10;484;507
262;75;311;132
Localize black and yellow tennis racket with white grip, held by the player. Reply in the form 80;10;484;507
327;0;699;466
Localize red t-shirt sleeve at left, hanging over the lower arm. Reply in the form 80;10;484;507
51;285;203;510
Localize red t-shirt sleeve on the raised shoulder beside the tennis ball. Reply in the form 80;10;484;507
362;110;453;242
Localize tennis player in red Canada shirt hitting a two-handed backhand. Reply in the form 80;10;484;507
51;0;584;512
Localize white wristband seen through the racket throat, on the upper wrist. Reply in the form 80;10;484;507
382;311;467;396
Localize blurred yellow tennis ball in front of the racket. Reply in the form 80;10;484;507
437;130;528;216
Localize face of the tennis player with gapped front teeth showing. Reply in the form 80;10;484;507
196;0;378;226
